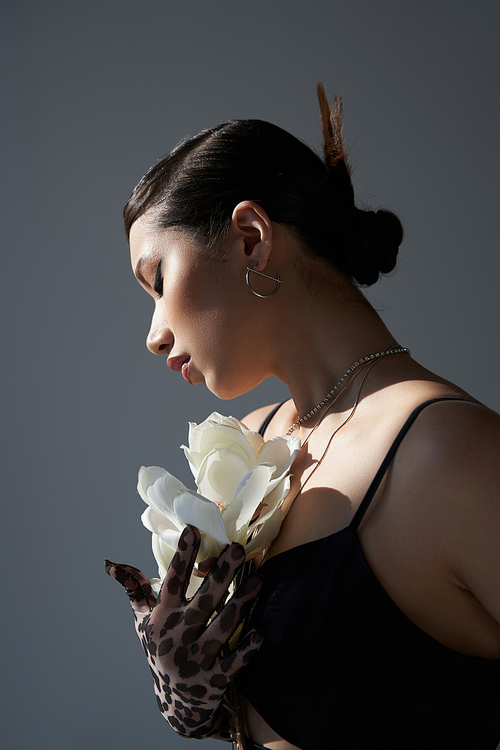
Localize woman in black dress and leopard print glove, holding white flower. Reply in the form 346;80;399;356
105;87;500;750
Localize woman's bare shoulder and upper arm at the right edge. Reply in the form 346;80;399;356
394;401;500;622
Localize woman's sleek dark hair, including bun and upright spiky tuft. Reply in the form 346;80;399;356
124;84;403;286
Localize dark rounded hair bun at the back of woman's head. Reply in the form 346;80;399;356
349;208;403;286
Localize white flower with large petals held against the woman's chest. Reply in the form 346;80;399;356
137;412;300;595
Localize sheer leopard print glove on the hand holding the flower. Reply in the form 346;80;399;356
105;526;262;740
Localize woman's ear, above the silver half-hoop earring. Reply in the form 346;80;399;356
231;201;273;272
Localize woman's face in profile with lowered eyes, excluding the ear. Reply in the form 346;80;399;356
130;215;270;398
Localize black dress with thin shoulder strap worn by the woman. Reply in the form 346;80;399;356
238;399;500;750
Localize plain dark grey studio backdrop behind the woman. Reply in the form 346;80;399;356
0;0;500;750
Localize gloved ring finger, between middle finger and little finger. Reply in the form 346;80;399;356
202;573;263;663
